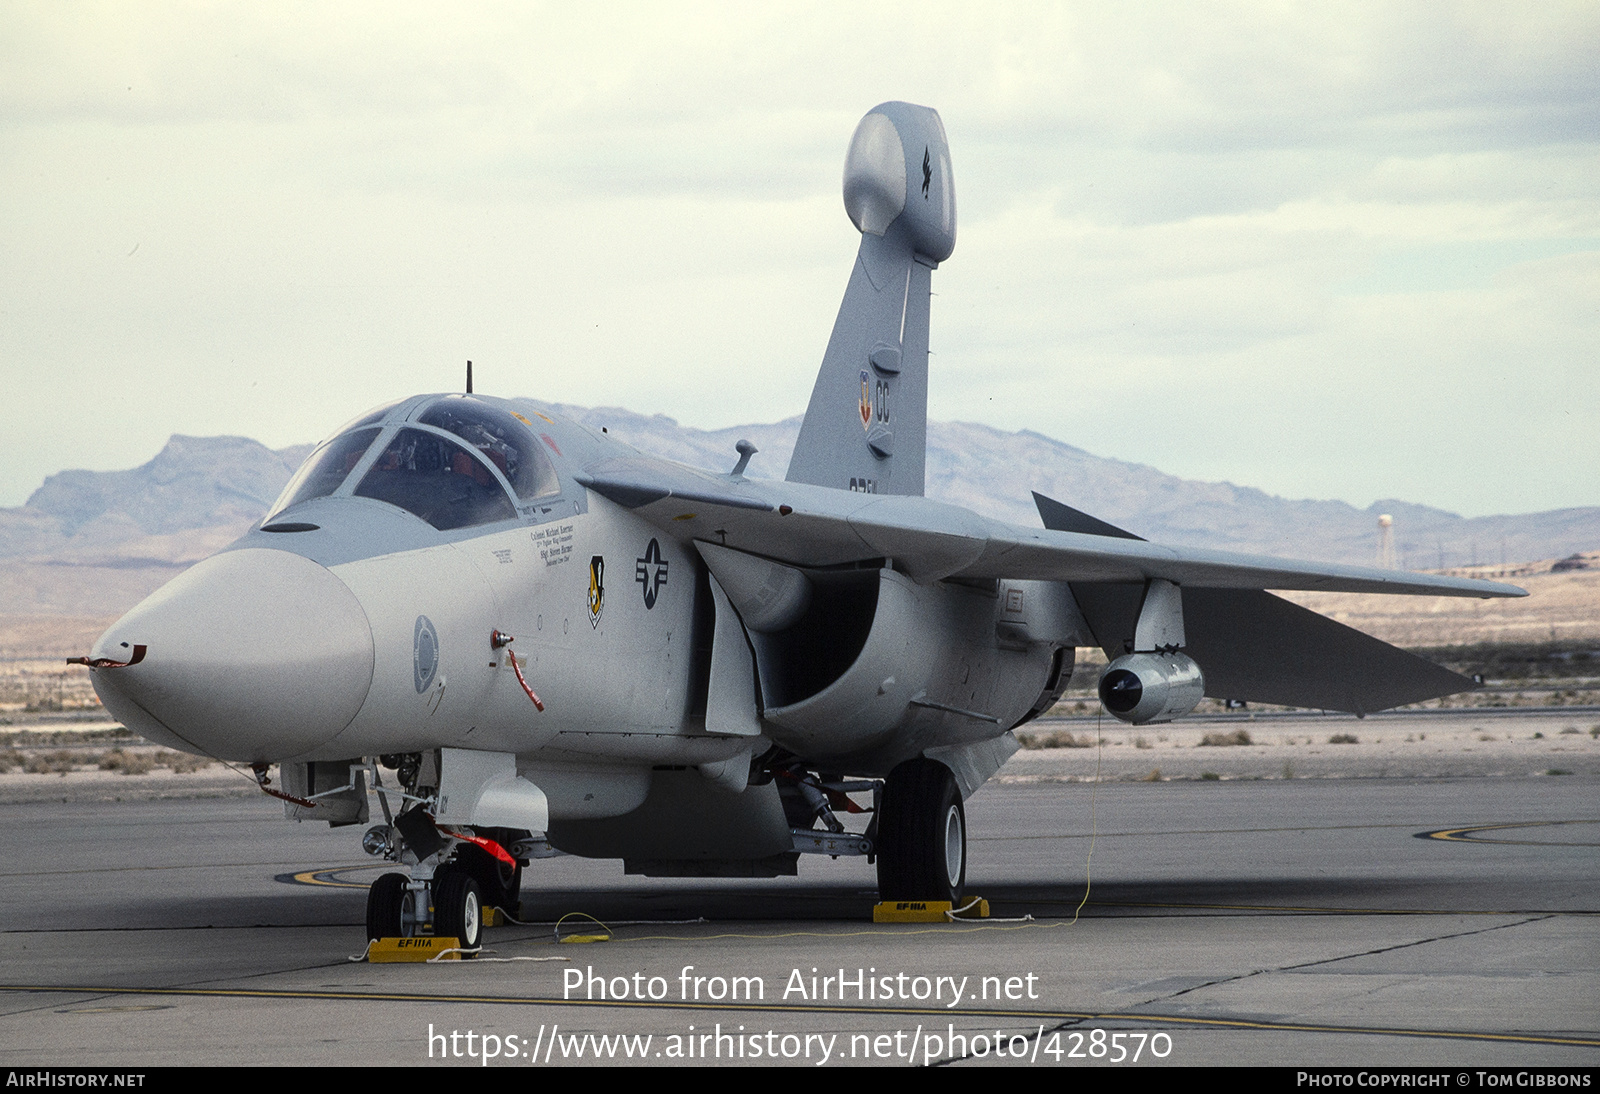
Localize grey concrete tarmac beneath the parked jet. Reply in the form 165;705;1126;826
0;748;1600;1068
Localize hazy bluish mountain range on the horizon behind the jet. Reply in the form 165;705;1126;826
0;403;1600;575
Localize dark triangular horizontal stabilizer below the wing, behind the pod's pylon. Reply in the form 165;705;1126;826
1072;582;1474;713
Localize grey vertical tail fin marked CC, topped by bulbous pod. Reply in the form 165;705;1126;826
786;102;955;494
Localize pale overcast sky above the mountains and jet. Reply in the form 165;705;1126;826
0;2;1600;515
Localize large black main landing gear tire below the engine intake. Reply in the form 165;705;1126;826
877;757;966;904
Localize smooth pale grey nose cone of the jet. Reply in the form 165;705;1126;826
91;549;373;761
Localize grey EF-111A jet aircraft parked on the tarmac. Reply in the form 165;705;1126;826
83;102;1525;947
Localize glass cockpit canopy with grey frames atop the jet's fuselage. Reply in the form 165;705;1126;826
264;395;562;531
